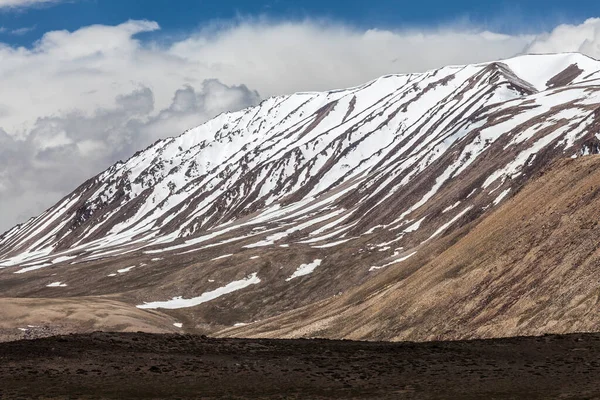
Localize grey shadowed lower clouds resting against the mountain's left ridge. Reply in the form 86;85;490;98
0;80;259;228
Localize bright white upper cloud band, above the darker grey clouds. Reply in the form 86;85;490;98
0;21;532;139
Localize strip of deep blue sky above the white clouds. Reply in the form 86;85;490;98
0;0;600;46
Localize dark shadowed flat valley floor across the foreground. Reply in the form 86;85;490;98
0;333;600;399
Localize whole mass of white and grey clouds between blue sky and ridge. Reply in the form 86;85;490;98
0;18;600;231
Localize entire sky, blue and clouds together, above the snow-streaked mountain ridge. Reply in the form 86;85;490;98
0;0;600;232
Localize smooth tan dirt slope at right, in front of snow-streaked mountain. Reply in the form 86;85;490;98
221;156;600;341
